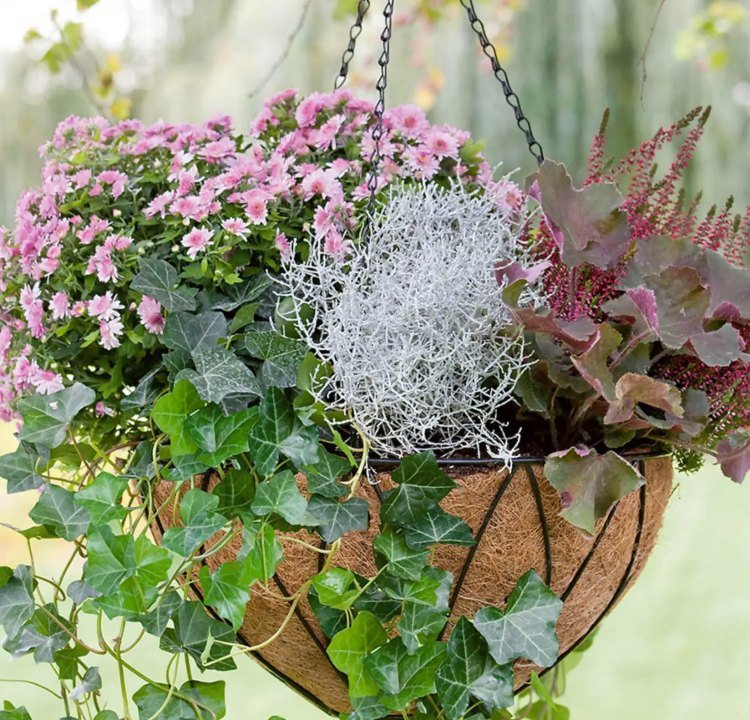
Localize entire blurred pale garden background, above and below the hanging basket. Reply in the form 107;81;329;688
0;0;750;720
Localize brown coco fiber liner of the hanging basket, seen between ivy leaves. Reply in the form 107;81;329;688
154;456;673;714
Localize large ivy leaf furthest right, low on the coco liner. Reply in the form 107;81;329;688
474;570;562;667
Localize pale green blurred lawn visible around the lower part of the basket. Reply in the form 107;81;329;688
0;427;750;720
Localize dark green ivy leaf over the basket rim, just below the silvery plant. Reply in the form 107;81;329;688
380;452;456;526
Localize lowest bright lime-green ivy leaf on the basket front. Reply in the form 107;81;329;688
328;612;388;698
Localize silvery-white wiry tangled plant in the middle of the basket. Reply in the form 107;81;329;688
279;184;541;462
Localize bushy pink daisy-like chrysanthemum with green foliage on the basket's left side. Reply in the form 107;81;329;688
0;90;520;419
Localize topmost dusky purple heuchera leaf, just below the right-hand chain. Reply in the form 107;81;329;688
529;160;632;268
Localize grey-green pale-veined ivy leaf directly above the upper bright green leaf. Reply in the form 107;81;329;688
176;347;261;403
